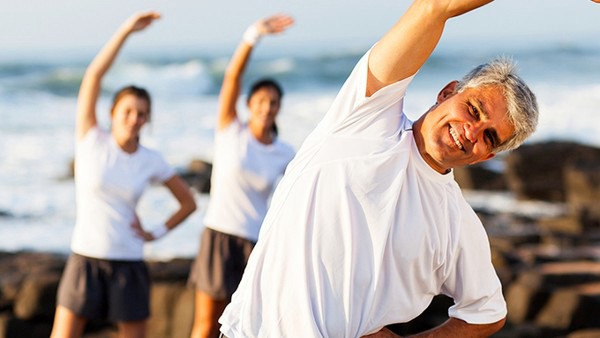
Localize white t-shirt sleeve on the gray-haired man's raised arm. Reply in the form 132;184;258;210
316;49;414;138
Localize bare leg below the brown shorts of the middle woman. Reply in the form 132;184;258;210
191;291;228;338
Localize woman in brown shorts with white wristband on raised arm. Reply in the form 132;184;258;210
190;15;294;338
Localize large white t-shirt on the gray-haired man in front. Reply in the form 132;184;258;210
220;48;506;338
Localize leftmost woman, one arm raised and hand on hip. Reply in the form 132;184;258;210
51;12;196;338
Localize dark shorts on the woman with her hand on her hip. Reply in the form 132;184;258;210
57;254;150;322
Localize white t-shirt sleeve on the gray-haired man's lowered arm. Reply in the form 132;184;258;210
442;202;507;324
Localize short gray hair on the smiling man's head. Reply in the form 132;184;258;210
456;57;539;152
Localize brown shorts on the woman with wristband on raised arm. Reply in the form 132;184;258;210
188;228;255;300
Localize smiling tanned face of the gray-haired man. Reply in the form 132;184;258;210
414;81;514;173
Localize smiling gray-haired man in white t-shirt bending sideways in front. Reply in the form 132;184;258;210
220;0;564;338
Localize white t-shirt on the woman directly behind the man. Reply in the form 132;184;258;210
204;120;294;242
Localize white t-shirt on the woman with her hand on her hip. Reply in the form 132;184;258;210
71;127;175;260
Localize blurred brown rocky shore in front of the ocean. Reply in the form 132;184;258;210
0;142;600;338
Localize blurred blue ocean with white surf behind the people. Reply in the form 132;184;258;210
0;43;600;259
